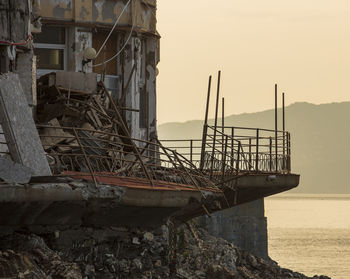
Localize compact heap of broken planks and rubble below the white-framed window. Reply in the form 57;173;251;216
36;73;135;173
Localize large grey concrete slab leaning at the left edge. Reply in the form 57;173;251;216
0;73;51;176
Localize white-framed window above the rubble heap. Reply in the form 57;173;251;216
34;26;66;74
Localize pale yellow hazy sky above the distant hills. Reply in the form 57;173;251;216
157;0;350;124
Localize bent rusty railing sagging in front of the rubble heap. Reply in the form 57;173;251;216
37;125;215;191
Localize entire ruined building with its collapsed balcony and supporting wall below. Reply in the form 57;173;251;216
0;0;299;264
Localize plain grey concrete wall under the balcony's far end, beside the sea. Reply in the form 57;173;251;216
198;199;268;258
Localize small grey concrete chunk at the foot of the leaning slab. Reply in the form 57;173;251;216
0;157;32;184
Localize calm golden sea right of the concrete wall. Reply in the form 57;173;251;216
265;194;350;279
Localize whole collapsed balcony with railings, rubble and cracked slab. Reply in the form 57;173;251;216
0;73;299;226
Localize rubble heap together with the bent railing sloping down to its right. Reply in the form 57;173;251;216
35;72;214;190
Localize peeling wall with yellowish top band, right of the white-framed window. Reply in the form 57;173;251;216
33;0;159;140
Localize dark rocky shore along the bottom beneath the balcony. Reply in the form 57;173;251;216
0;223;329;279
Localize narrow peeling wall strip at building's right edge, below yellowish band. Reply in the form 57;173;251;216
113;34;159;140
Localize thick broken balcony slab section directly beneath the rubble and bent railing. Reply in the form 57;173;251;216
0;177;222;228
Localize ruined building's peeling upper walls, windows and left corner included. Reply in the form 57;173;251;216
0;0;159;140
